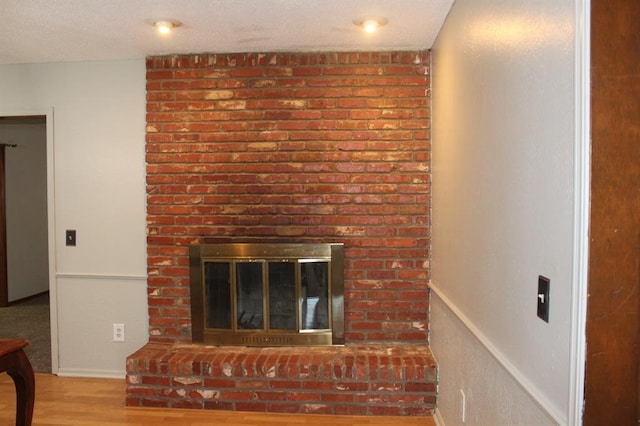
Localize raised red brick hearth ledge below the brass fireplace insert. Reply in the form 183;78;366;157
127;343;436;416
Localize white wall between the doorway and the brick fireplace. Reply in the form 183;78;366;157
0;59;148;375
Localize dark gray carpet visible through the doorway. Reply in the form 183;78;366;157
0;293;51;373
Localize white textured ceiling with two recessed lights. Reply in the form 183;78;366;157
0;0;453;64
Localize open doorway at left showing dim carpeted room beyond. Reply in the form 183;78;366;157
0;115;52;372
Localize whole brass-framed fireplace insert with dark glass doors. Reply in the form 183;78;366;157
189;243;344;346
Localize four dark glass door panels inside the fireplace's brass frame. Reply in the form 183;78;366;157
204;260;329;331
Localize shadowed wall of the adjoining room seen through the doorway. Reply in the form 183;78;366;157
0;118;49;302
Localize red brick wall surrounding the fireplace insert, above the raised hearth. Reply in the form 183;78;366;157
146;52;430;344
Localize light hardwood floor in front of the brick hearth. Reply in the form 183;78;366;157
0;374;435;426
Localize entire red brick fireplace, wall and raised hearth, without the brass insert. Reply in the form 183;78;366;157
127;51;436;415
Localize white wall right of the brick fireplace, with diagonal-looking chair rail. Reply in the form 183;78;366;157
431;0;586;426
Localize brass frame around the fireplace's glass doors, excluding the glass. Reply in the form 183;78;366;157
189;243;344;346
